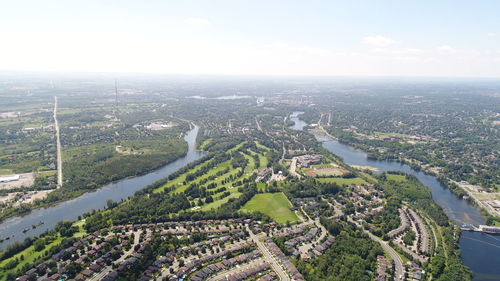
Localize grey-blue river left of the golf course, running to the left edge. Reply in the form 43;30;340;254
0;126;203;249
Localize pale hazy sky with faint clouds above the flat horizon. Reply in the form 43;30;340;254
0;0;500;77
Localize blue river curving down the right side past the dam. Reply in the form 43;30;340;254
290;112;500;281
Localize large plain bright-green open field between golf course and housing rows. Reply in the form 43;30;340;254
241;192;298;223
